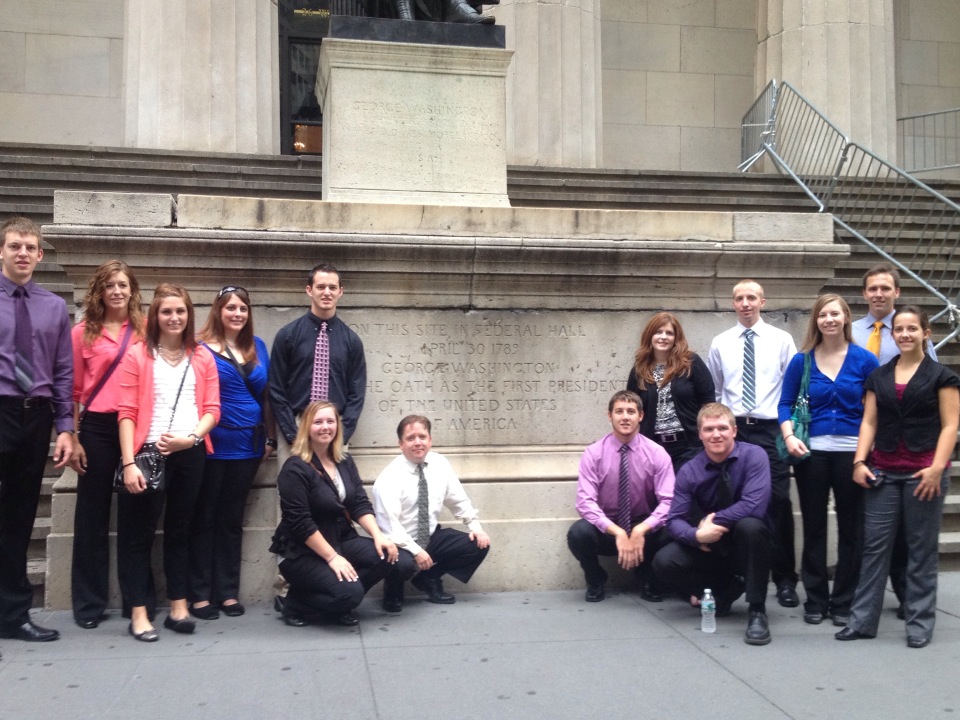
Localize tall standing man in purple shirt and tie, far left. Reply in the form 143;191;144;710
0;217;73;642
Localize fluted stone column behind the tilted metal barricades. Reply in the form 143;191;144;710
757;0;897;160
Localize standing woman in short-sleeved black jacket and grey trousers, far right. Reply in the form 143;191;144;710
834;305;960;648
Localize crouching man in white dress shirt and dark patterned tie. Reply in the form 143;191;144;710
373;415;490;613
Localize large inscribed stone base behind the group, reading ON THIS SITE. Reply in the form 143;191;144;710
44;193;847;608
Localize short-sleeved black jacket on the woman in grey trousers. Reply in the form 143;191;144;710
863;355;960;452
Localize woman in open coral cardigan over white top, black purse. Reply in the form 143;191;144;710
117;283;220;642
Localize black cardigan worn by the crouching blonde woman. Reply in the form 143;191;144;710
270;456;373;560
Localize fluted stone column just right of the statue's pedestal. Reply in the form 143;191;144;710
492;0;603;168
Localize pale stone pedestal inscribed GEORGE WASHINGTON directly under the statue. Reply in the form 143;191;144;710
317;20;512;206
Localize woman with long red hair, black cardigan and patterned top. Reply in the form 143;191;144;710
627;312;717;472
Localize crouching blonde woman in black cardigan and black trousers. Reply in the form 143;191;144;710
270;400;416;627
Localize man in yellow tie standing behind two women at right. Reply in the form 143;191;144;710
851;263;937;620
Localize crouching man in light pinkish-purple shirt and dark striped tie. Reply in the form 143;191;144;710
567;390;673;602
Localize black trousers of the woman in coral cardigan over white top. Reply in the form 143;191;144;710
117;444;207;607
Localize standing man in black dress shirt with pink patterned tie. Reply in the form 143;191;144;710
270;263;367;445
